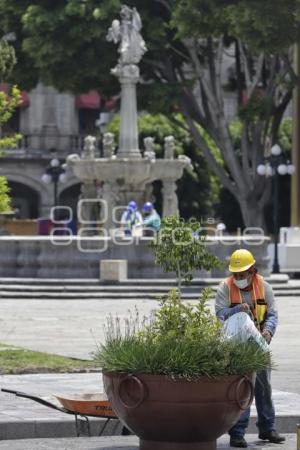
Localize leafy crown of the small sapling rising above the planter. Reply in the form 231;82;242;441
150;216;222;293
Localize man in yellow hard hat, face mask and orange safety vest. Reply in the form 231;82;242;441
215;249;285;448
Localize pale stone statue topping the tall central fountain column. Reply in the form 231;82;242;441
106;5;147;66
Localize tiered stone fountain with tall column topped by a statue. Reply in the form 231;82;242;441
67;5;191;230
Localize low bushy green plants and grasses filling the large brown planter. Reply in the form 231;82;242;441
96;289;272;379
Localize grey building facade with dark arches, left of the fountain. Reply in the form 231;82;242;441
0;84;101;219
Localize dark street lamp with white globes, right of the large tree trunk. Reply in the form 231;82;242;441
256;144;295;273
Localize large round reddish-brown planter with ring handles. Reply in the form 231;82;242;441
103;372;255;450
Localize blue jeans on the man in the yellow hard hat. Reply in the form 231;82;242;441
228;370;275;437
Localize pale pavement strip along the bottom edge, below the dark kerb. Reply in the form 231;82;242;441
0;434;296;450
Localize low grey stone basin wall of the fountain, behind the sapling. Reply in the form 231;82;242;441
0;236;270;278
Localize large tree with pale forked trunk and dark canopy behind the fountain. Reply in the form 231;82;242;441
0;0;300;226
